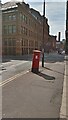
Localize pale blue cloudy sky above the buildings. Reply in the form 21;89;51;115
1;0;66;41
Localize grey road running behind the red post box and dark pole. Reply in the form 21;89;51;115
0;53;64;81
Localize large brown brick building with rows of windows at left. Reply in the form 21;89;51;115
2;2;49;55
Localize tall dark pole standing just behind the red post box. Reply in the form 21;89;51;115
42;0;45;67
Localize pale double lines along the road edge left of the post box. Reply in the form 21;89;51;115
0;71;29;87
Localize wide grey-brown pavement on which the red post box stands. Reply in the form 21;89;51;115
2;62;65;120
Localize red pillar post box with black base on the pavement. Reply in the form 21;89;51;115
32;50;41;73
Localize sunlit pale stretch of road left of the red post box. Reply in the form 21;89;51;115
2;60;31;81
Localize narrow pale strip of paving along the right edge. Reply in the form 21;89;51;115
60;56;68;120
